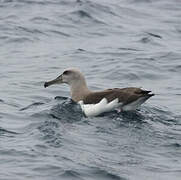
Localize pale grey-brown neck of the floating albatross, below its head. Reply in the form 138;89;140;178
70;80;91;102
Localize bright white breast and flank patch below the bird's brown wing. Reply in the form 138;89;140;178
78;98;122;117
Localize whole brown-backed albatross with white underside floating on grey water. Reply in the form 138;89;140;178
44;68;154;116
